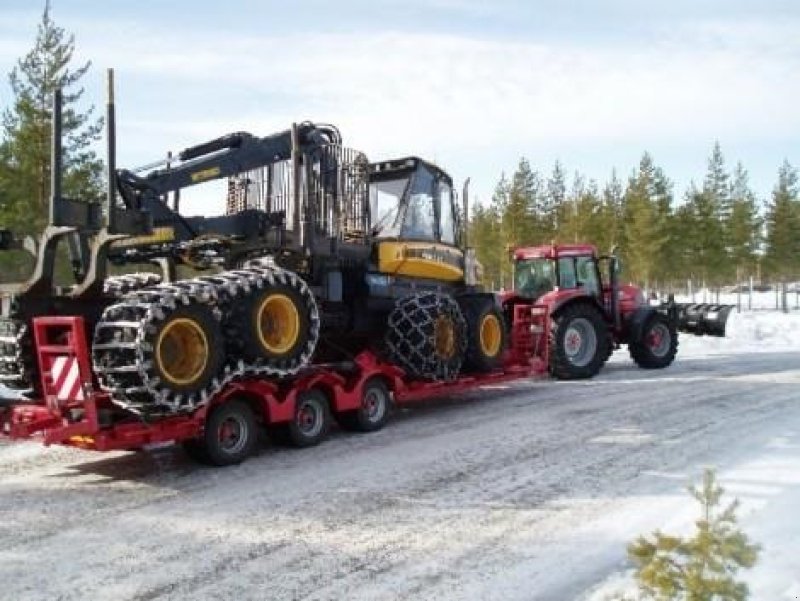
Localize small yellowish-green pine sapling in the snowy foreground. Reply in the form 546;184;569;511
628;470;760;601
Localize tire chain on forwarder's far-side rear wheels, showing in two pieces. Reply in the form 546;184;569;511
0;273;161;391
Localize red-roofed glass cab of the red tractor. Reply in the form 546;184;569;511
514;244;603;300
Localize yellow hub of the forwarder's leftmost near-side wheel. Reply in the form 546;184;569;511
156;317;210;386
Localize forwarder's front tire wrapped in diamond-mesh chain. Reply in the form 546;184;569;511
385;292;467;381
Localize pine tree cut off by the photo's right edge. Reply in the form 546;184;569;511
764;161;800;278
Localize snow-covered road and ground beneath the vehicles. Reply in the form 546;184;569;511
0;314;800;601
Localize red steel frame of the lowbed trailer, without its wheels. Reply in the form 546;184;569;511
0;304;549;462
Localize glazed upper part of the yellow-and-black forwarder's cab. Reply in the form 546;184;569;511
369;157;458;246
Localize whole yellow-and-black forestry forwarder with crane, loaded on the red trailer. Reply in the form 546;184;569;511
0;72;506;419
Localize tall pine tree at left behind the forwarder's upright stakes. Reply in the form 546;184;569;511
0;2;102;240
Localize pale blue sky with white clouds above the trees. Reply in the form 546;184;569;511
0;0;800;213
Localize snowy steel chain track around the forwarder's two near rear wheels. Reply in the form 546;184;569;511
92;260;320;414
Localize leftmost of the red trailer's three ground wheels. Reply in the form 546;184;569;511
183;400;258;466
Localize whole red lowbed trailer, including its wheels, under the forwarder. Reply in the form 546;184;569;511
0;304;549;465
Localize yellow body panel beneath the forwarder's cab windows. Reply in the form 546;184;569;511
378;241;464;282
